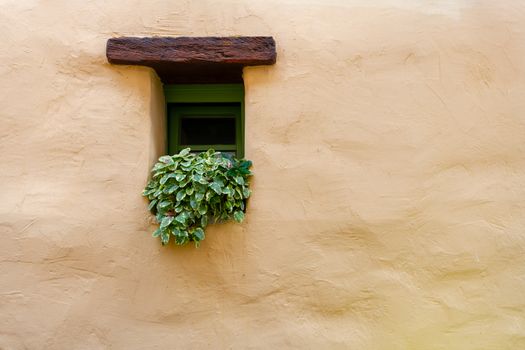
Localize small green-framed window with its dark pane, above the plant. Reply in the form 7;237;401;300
164;84;244;157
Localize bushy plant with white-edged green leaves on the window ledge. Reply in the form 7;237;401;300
143;148;252;246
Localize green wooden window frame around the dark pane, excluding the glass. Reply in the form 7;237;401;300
164;84;244;157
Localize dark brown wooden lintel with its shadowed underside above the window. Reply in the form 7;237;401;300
106;36;276;83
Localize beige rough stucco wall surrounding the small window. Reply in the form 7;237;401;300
0;0;525;350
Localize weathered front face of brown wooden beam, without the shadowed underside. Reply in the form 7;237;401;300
106;36;276;67
